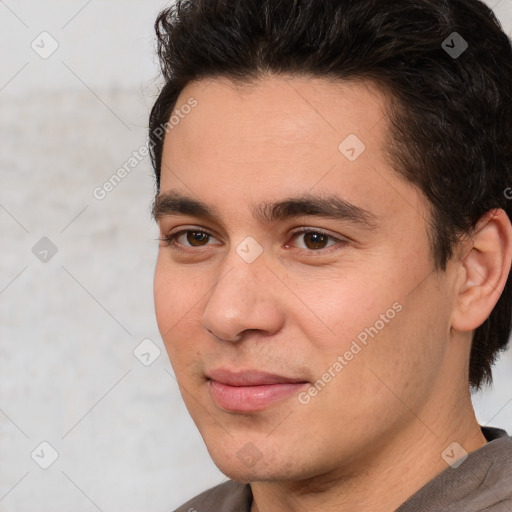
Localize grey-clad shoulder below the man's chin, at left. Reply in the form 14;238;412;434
175;480;252;512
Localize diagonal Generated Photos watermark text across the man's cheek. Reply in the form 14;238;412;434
297;302;403;405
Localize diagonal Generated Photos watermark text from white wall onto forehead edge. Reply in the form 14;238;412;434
92;97;197;201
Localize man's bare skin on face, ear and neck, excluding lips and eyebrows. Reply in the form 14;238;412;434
154;76;512;512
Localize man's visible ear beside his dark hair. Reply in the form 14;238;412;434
452;209;512;331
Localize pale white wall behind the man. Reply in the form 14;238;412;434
0;0;512;512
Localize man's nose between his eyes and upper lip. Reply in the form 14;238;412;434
201;253;284;342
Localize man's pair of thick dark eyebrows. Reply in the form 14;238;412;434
152;191;380;230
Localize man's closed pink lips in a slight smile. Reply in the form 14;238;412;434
208;369;309;412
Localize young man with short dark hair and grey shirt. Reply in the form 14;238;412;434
150;0;512;512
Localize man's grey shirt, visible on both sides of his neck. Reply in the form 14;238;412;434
175;427;512;512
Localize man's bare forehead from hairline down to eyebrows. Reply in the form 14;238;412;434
161;76;426;227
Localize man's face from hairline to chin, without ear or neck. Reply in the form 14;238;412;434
154;77;453;482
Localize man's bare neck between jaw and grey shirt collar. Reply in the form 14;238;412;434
251;382;486;512
